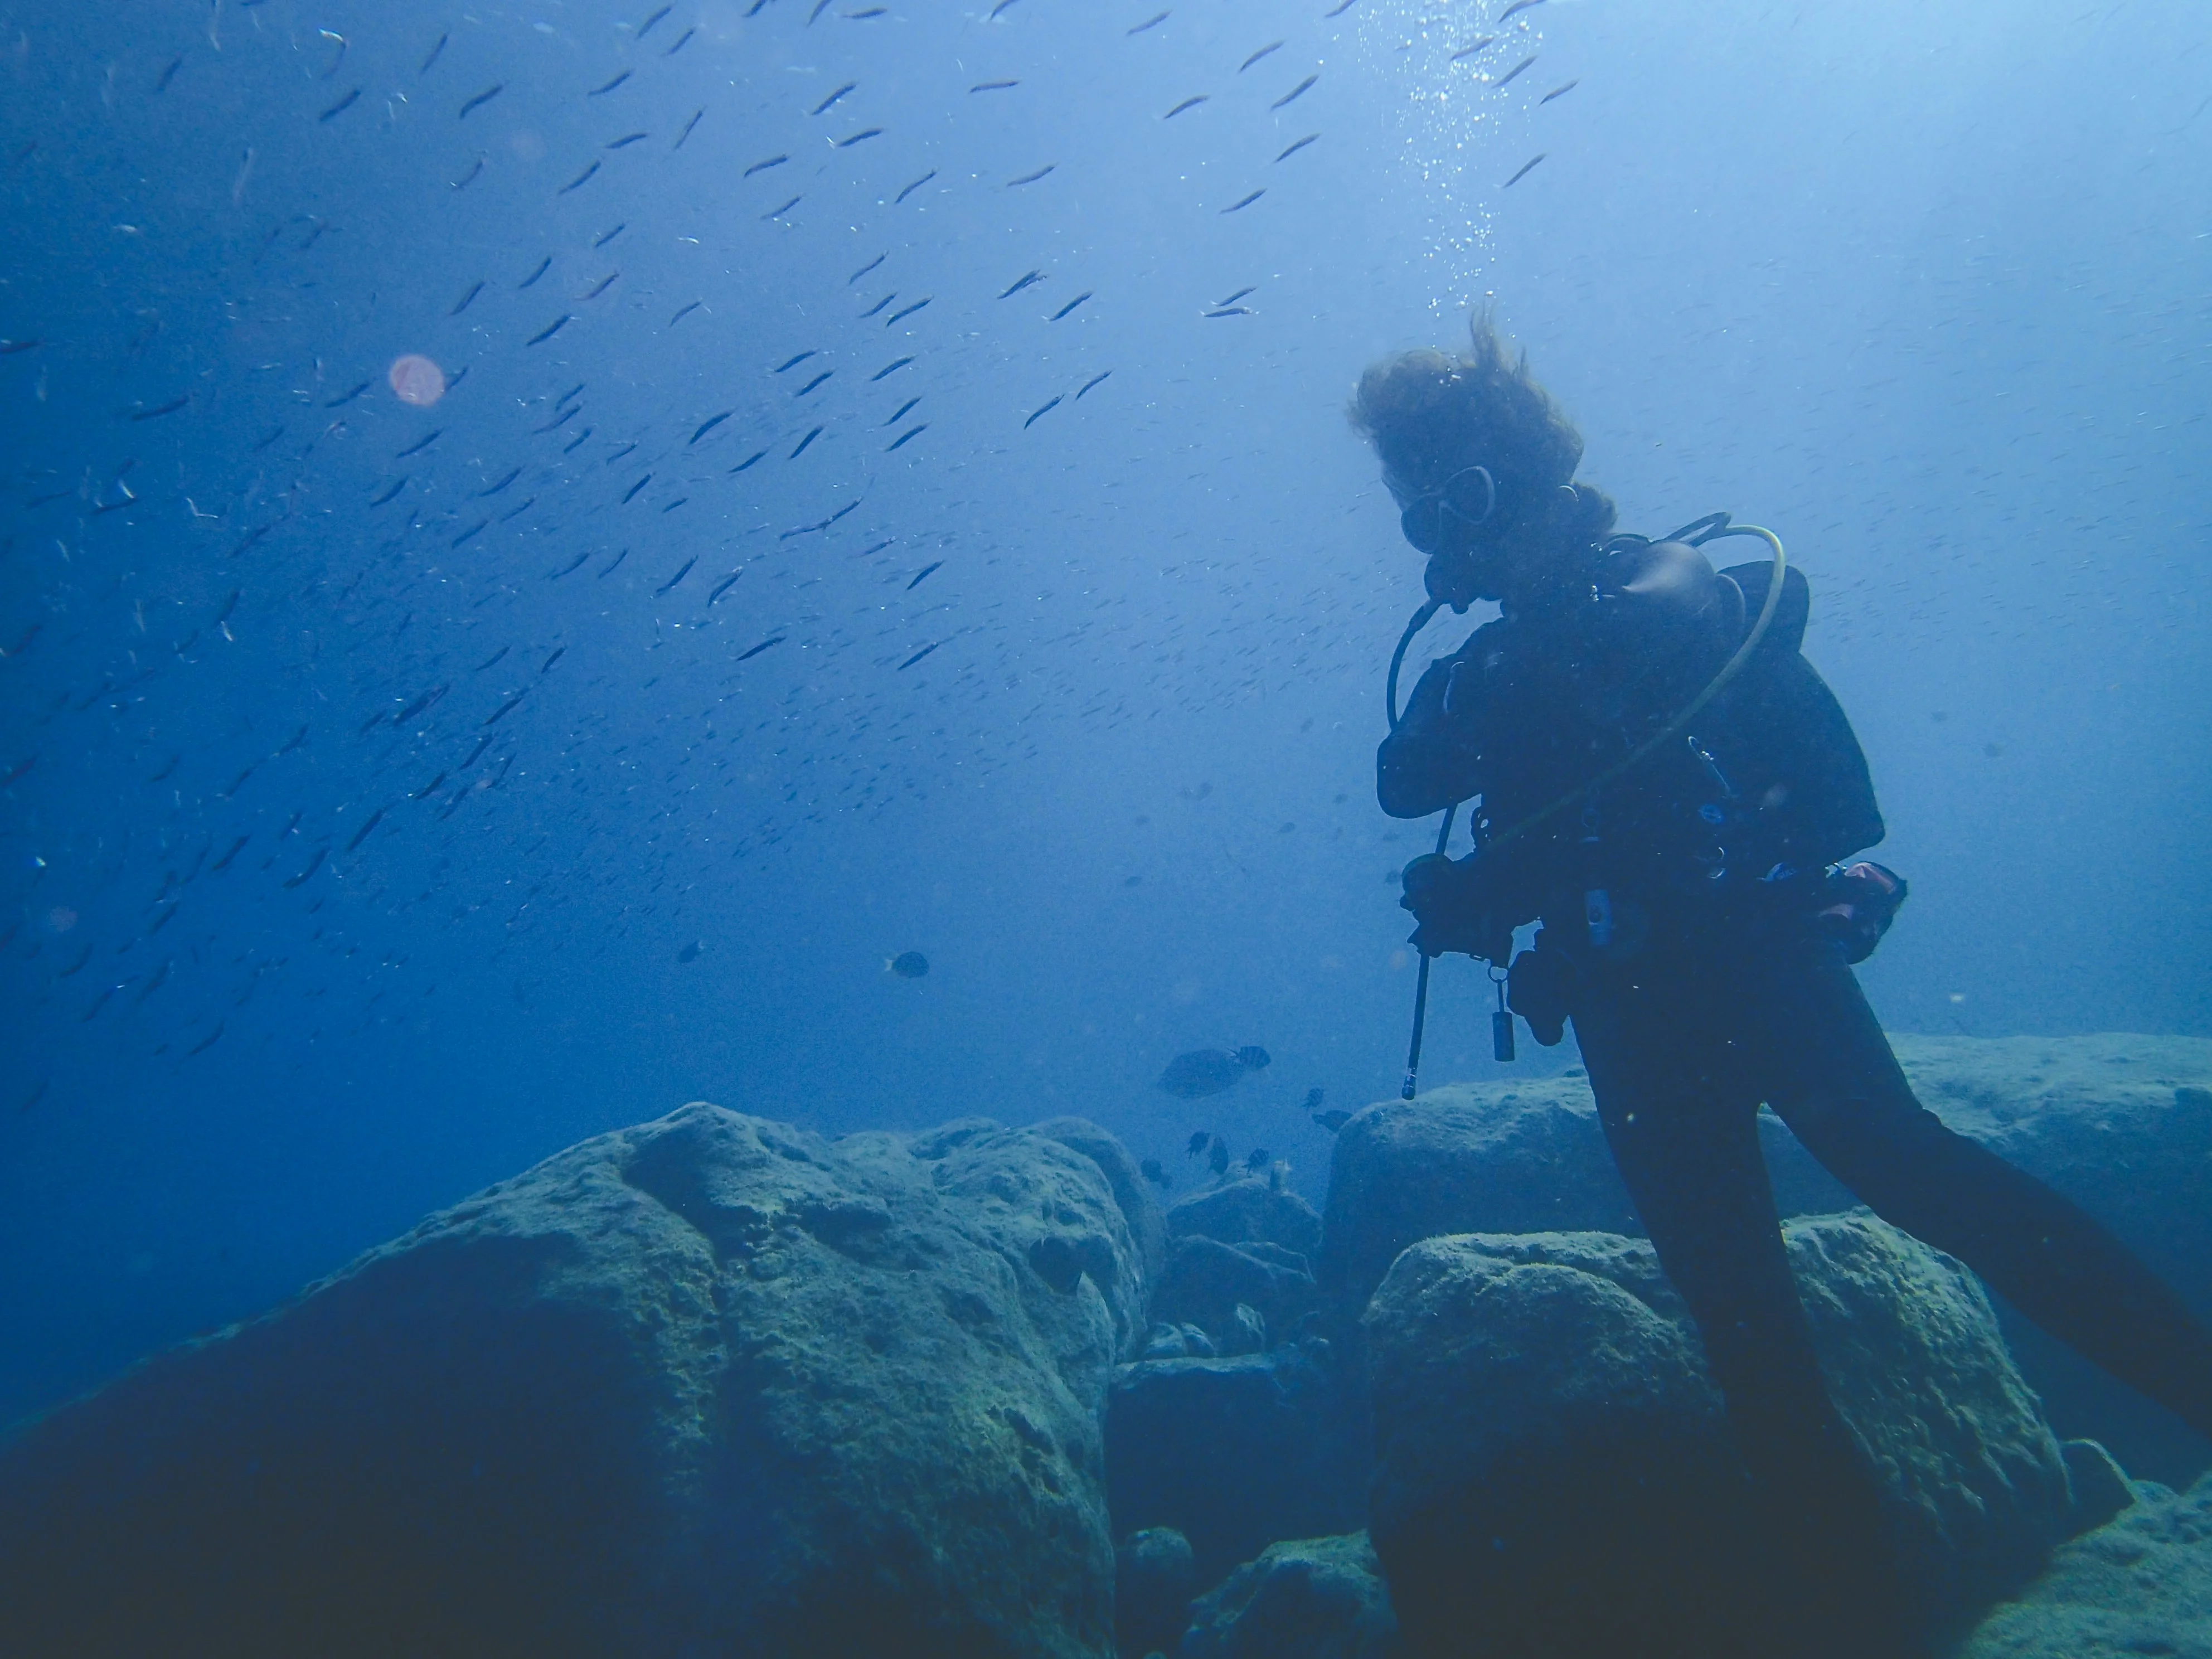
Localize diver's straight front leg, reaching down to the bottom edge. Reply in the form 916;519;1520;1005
1575;973;1909;1659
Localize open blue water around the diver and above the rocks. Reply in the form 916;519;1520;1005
0;0;2212;1420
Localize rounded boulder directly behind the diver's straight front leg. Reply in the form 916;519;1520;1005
1367;1216;2070;1659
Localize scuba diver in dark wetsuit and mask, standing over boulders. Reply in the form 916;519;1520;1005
1351;316;2212;1655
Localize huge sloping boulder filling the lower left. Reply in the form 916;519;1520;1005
0;1104;1146;1659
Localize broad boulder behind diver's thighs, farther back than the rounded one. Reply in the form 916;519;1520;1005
1316;1033;2212;1482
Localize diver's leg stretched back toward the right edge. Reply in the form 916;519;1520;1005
1765;951;2212;1435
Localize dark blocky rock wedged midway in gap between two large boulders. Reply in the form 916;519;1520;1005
1106;1338;1369;1584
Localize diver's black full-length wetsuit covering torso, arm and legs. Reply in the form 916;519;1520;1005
1378;544;2212;1652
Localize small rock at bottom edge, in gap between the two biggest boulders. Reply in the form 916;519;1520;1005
1181;1533;1398;1659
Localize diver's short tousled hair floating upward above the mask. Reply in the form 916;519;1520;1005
1347;312;1613;535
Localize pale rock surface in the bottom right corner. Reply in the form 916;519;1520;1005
1958;1476;2212;1659
